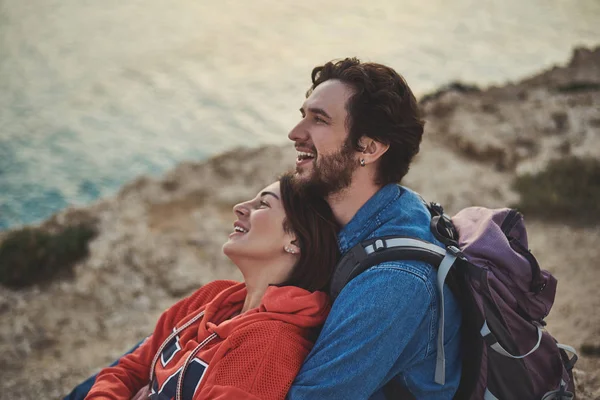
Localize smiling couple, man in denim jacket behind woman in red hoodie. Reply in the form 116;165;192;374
79;59;461;400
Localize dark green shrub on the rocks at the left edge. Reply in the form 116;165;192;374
0;224;97;289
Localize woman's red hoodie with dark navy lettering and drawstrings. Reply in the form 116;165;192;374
86;281;329;400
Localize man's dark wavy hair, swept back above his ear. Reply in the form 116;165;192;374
306;58;425;185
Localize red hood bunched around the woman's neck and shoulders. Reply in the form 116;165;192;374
200;283;330;339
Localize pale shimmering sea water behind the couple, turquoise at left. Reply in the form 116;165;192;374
0;0;600;230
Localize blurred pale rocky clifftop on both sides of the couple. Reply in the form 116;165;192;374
0;48;600;399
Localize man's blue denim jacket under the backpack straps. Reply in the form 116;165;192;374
288;185;461;400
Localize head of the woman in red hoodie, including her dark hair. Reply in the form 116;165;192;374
223;174;339;291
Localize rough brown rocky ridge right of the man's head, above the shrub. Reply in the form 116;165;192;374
422;47;600;174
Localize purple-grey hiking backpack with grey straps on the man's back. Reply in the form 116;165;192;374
330;202;577;400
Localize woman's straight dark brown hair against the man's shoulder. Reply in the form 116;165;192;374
278;173;340;292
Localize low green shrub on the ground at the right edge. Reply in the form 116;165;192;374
514;157;600;225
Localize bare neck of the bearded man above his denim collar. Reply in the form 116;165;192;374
327;174;381;226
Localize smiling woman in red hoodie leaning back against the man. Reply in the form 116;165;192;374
86;174;339;399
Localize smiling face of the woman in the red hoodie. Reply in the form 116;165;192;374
223;182;297;261
